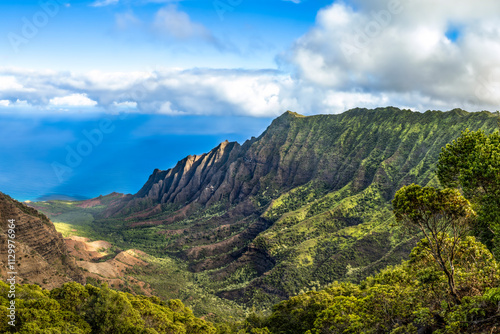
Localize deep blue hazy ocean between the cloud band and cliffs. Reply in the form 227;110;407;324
0;114;270;201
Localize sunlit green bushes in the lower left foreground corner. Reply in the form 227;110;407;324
0;282;216;334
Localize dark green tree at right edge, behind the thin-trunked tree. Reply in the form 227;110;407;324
437;130;500;257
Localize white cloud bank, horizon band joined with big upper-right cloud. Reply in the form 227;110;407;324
0;0;500;117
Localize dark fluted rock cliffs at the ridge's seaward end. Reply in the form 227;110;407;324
128;112;300;210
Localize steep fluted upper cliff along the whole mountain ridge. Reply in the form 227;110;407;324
128;107;495;211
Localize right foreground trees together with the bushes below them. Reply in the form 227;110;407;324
220;130;500;334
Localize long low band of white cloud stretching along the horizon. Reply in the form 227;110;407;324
0;62;500;117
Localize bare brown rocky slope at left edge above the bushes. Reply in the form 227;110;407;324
0;193;84;288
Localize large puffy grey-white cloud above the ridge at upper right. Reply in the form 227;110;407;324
284;0;500;108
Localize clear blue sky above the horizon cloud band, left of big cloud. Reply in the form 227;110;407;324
0;0;329;71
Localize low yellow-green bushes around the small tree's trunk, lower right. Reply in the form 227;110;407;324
229;237;500;334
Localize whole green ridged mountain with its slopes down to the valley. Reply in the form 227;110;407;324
32;107;497;316
